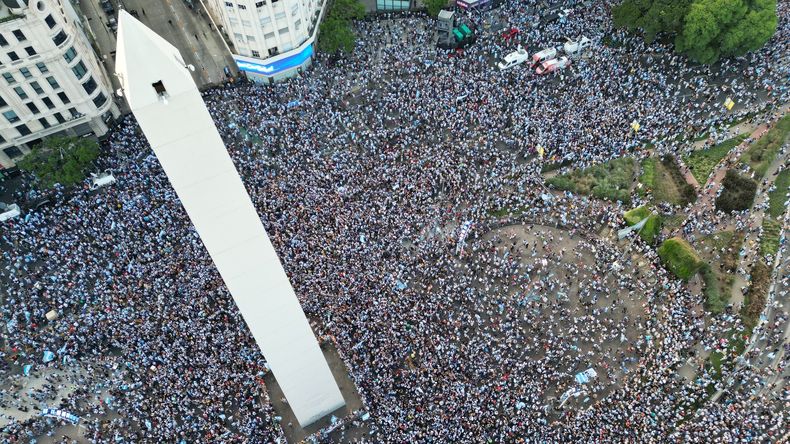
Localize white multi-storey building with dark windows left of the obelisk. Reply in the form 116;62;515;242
0;0;120;169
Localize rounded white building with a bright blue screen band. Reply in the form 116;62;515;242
209;0;326;82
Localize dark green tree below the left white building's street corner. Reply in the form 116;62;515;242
17;136;99;188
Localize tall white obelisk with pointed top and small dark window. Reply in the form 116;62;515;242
115;10;345;427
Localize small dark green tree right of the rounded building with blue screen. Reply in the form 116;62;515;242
318;0;365;54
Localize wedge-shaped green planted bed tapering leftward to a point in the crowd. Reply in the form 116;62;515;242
546;157;636;204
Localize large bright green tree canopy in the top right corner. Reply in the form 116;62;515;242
612;0;778;63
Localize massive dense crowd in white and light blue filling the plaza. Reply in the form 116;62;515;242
0;1;790;443
